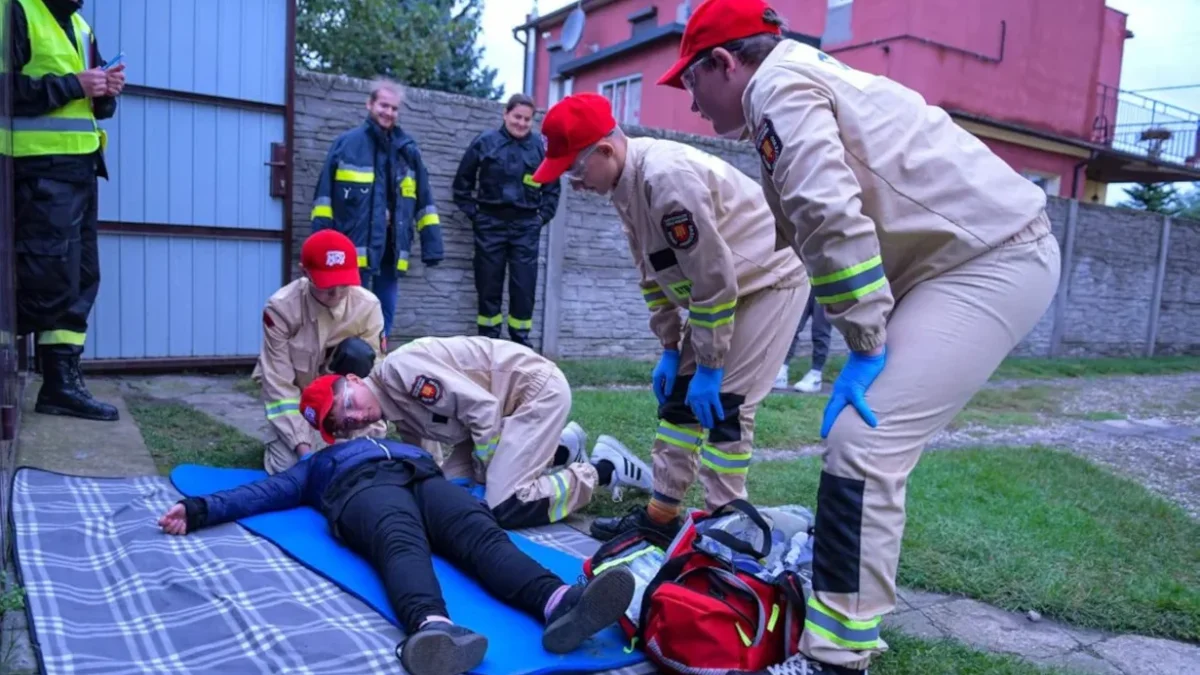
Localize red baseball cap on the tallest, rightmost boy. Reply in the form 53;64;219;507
659;0;782;89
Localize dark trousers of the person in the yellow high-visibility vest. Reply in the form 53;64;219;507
13;178;100;350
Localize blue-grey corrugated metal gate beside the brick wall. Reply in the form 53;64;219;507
83;0;295;368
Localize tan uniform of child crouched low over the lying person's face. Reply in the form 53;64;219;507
365;336;599;528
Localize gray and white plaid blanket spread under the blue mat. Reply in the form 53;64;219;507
12;468;654;675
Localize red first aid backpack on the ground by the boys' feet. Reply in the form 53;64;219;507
583;500;804;675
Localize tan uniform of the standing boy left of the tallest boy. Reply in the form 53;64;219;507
612;138;809;509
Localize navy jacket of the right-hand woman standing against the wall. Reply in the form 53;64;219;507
454;125;560;225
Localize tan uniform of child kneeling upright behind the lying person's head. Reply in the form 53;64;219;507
251;279;388;473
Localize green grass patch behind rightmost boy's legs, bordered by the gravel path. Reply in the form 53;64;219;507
590;448;1200;641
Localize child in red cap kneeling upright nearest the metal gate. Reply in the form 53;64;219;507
251;229;388;473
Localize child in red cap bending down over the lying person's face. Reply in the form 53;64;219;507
300;336;652;528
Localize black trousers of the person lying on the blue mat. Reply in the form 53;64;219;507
337;472;563;634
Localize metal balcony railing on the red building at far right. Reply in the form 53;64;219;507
1092;84;1200;167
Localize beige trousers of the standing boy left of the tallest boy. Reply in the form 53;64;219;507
650;281;809;509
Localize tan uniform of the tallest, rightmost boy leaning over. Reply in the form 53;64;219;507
743;40;1060;669
